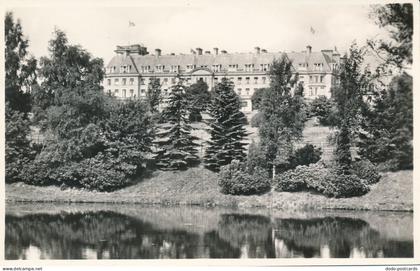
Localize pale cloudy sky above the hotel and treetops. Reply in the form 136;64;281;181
7;0;388;63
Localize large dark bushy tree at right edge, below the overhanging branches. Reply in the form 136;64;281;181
358;73;413;170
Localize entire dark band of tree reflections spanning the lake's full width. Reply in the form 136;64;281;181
5;212;413;259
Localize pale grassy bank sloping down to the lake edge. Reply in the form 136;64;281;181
6;168;413;211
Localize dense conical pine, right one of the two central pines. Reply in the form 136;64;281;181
204;78;247;171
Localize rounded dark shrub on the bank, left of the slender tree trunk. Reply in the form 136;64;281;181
218;160;270;195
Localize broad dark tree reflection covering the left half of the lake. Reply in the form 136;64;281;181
5;212;200;259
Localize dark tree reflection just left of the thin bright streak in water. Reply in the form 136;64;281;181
213;214;275;258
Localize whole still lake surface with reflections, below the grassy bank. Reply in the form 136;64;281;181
5;203;413;260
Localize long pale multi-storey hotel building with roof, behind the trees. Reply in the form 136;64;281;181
104;44;340;113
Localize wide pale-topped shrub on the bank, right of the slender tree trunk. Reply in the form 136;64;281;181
275;163;369;198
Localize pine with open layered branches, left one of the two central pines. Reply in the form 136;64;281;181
155;78;199;170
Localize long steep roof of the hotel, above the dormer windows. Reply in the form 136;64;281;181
107;47;338;73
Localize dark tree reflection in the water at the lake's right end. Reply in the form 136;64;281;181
275;217;413;258
